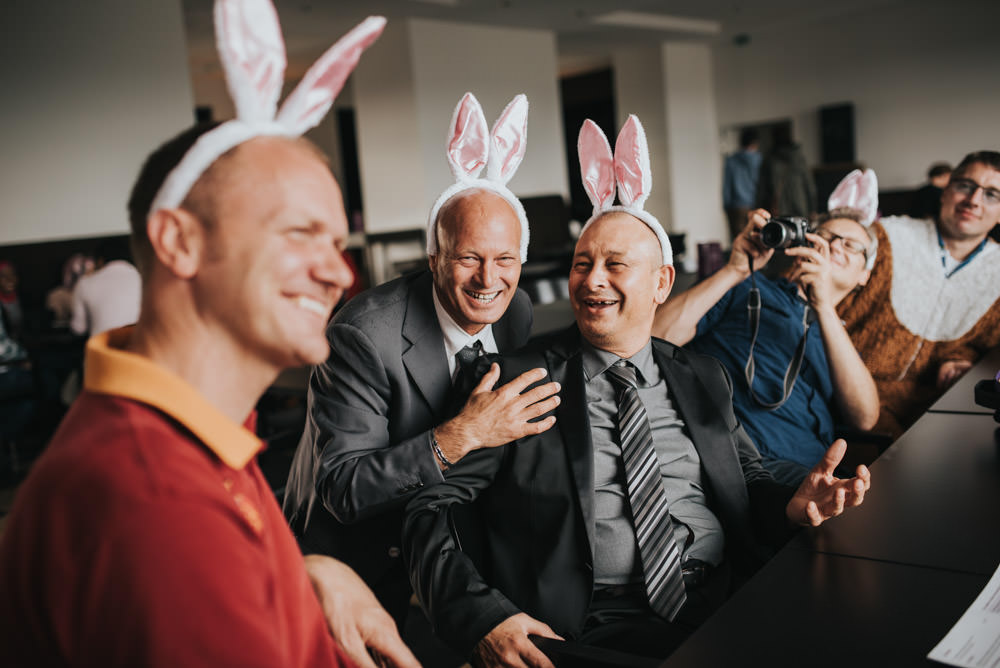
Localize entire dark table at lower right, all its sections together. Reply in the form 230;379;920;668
663;351;1000;668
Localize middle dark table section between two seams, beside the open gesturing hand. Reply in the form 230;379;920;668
791;413;1000;574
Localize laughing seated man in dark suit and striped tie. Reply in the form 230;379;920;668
403;208;869;667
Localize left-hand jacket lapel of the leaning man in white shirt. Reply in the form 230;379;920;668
403;272;451;417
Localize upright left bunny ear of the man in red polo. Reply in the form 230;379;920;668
215;0;285;123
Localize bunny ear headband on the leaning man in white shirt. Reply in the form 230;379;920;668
427;93;528;263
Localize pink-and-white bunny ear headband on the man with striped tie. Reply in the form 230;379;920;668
576;114;674;264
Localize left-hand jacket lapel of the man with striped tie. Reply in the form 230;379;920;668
546;326;594;554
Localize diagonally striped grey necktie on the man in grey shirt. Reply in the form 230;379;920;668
608;360;687;621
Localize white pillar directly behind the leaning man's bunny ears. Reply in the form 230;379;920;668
354;20;568;232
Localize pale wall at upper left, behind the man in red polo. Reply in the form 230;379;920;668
0;0;194;244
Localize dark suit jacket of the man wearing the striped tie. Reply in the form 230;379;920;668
403;325;794;655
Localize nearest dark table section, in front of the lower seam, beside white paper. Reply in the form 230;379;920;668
662;549;989;668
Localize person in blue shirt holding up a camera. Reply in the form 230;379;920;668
653;172;878;485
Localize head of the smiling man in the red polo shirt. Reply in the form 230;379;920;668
140;130;354;374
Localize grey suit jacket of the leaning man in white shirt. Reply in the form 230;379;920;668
284;271;531;607
